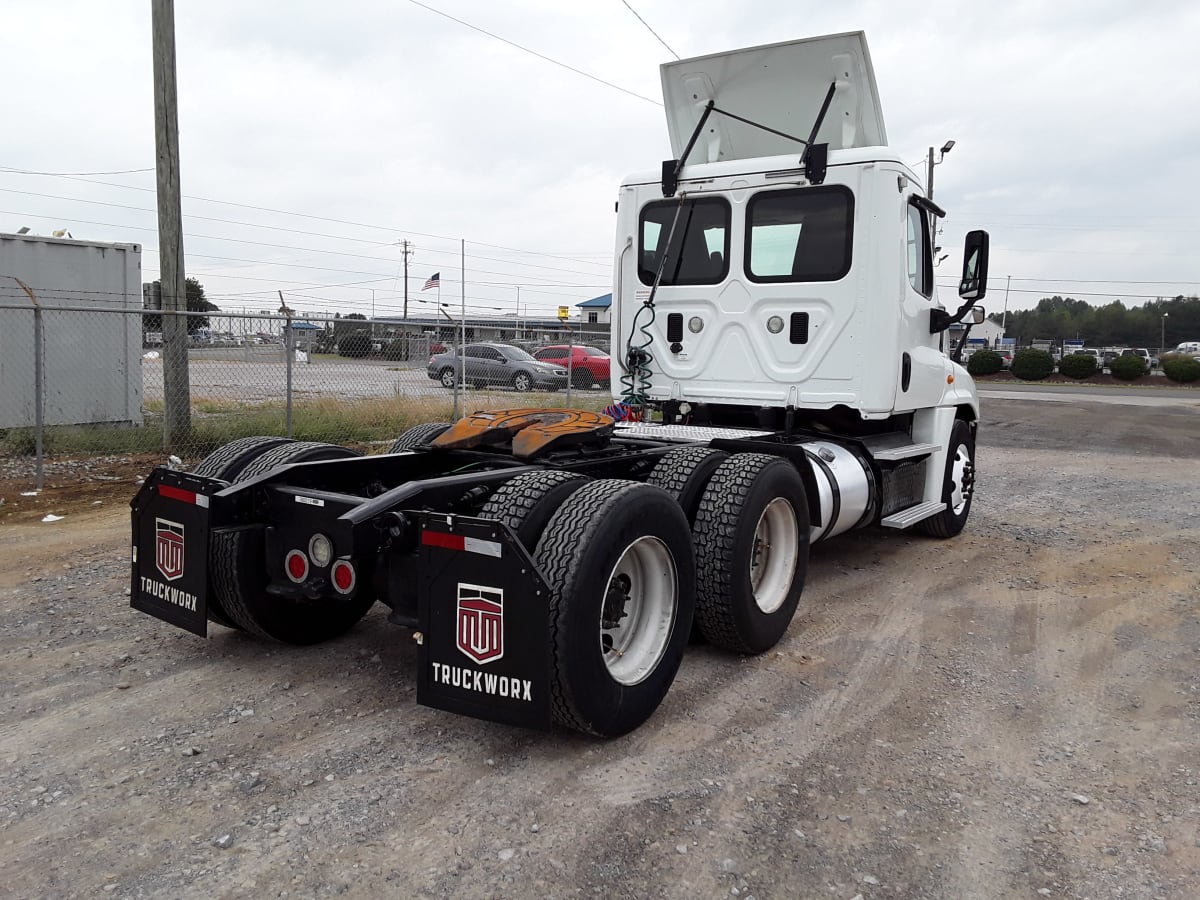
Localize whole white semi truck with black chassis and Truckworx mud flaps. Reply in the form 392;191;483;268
132;32;988;737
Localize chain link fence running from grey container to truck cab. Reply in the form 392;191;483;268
0;297;619;487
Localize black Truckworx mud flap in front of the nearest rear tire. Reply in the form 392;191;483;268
416;512;551;730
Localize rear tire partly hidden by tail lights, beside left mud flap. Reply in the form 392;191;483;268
209;442;374;644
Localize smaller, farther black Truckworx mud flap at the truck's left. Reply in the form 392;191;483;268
130;469;219;637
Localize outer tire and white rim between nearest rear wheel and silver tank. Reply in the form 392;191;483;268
692;454;809;653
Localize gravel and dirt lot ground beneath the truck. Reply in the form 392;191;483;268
0;398;1200;900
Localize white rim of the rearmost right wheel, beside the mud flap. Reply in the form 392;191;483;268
600;536;679;685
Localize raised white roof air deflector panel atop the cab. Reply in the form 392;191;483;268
662;31;888;162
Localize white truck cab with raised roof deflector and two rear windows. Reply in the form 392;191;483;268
612;32;978;434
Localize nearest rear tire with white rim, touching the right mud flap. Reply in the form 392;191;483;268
534;479;696;737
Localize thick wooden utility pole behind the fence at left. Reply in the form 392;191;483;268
150;0;192;450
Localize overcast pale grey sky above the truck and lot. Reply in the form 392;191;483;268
0;0;1200;324
